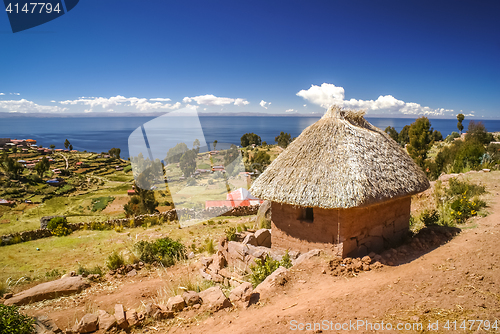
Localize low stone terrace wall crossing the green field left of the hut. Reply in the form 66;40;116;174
0;205;260;246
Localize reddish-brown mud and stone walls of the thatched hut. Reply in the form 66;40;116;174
271;196;411;257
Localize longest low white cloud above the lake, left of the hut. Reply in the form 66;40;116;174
59;95;181;112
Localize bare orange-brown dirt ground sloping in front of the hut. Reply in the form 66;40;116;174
21;172;500;334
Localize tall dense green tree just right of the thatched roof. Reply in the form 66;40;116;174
407;117;432;168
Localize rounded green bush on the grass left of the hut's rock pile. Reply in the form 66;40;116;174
134;237;186;267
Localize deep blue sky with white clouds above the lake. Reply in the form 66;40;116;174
0;0;500;119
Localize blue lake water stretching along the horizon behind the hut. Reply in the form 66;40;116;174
0;116;500;158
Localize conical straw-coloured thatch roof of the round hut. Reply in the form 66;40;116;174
250;107;429;209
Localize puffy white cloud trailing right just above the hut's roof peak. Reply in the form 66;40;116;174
297;83;453;116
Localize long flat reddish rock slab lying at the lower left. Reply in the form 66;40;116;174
5;276;89;305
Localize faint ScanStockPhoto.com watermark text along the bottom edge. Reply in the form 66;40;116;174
290;319;424;331
